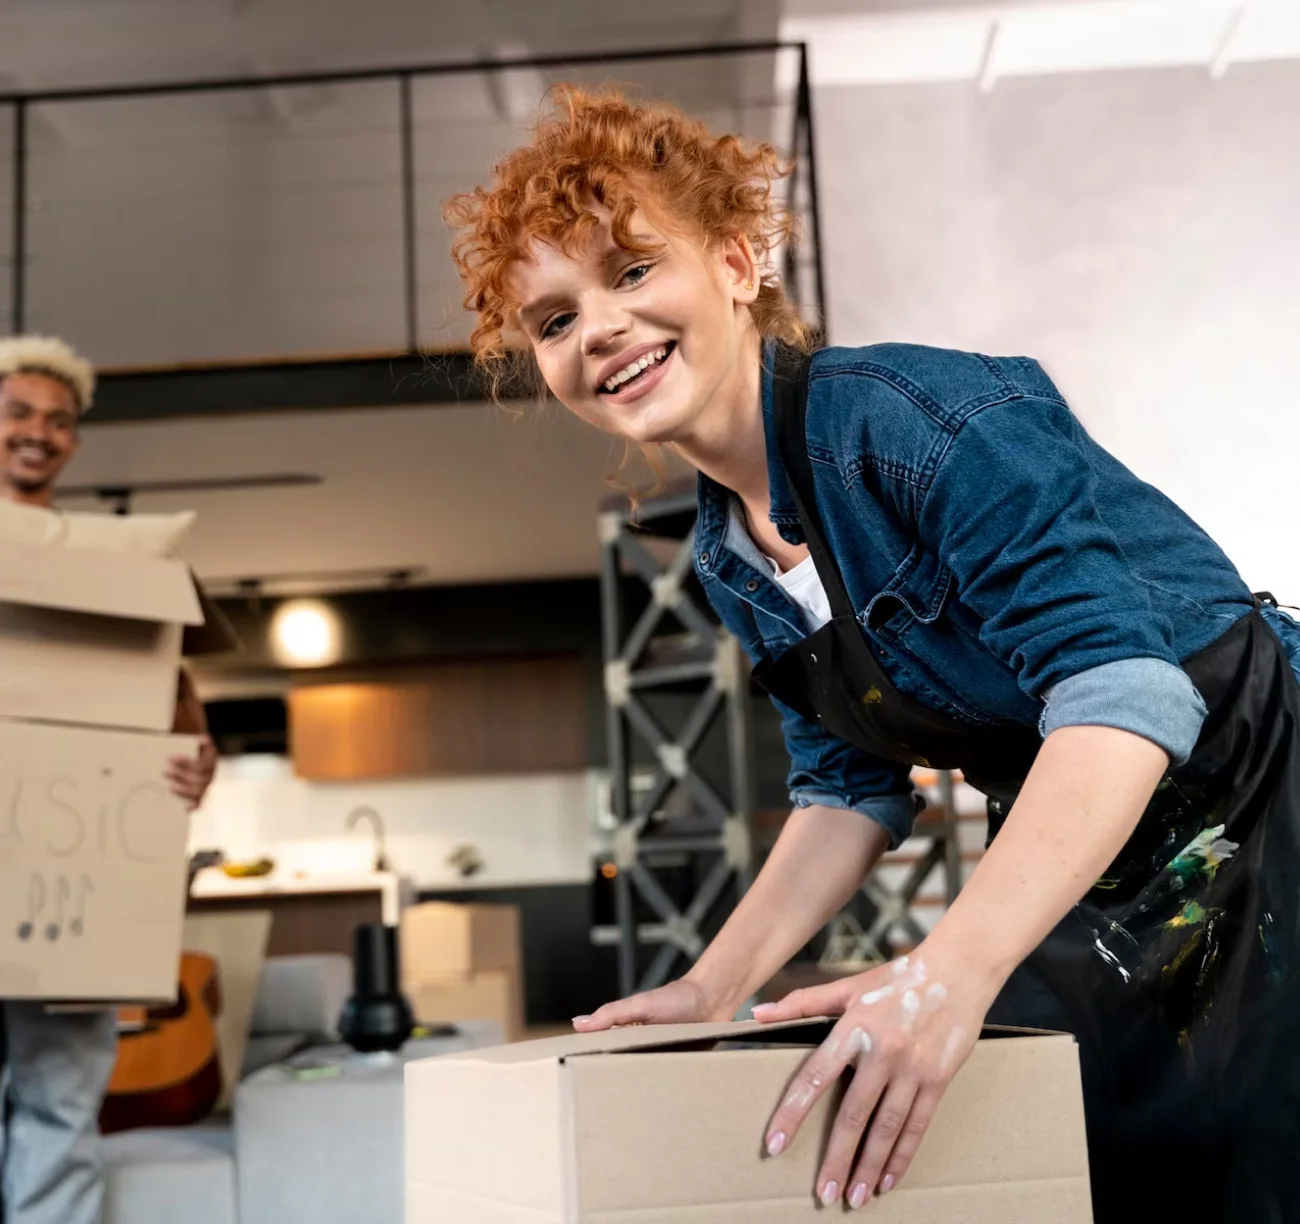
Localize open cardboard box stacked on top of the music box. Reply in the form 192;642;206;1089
0;539;204;732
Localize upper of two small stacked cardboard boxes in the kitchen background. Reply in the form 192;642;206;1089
398;900;523;986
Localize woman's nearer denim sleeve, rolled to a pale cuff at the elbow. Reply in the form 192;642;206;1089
918;396;1205;761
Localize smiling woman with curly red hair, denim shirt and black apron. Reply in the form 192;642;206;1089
447;90;1300;1224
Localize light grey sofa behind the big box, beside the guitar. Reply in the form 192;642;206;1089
104;956;501;1224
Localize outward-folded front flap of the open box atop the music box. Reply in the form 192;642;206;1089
0;541;203;625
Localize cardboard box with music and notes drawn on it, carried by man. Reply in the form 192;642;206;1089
0;722;198;1002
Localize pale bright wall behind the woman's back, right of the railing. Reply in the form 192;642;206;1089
815;62;1300;602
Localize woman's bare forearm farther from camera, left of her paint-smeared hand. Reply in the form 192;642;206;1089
686;804;889;1019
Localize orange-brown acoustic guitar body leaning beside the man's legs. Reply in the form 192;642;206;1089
99;952;221;1134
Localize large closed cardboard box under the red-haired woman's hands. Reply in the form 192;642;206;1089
406;1021;1092;1224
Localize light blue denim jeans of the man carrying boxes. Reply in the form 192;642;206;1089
0;1001;117;1224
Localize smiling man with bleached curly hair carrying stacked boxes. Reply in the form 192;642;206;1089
0;337;216;1224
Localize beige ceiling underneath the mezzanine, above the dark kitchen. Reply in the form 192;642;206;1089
64;404;683;589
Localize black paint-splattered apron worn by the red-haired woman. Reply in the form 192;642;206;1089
754;353;1300;1224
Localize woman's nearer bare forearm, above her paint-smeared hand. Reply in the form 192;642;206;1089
931;726;1169;981
